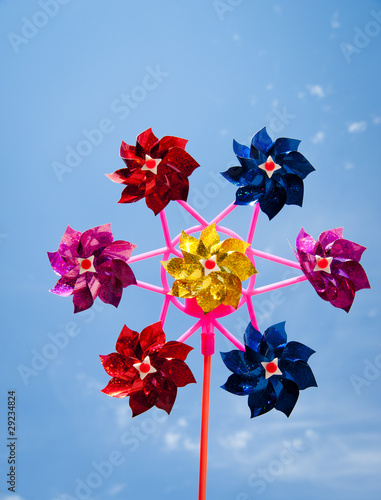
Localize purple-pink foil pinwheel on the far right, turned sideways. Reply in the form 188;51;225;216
296;228;370;312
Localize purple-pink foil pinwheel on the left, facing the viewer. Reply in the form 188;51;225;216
48;224;136;313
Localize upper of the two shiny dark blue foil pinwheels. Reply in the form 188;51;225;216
221;127;315;219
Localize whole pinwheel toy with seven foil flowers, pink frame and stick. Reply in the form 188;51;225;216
48;128;370;500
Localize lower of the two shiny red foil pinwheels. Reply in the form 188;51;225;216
100;321;196;417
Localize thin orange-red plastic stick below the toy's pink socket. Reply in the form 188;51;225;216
198;355;212;500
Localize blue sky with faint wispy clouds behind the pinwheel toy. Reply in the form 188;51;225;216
0;0;381;500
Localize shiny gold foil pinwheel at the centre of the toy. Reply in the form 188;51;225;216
162;224;257;313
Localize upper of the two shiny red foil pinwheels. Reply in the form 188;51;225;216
107;128;199;215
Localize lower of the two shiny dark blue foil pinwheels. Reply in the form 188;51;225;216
221;322;317;418
